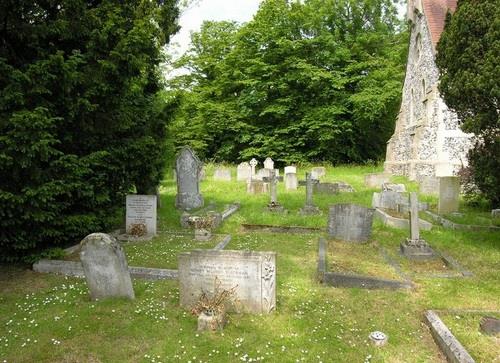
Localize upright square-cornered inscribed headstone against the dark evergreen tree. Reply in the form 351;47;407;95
125;194;157;237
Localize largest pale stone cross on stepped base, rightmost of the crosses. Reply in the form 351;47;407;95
400;192;436;260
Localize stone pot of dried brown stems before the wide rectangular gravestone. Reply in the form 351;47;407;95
191;277;238;331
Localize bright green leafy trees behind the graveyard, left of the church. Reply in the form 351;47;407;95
170;0;407;163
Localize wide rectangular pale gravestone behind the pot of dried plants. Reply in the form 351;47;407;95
178;250;276;314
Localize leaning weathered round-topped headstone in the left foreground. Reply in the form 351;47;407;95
80;233;135;300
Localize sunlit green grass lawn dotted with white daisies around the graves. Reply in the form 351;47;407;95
0;167;500;363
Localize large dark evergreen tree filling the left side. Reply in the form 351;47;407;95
0;0;178;260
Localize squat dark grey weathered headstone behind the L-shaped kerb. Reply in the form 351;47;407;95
328;203;375;242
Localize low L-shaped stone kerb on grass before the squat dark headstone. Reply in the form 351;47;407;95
318;237;413;289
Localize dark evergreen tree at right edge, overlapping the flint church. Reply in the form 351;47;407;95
436;0;500;206
